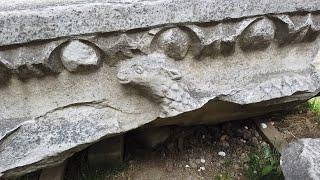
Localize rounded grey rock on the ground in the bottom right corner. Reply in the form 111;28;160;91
281;138;320;180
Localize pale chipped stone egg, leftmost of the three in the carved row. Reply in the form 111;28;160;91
61;40;100;72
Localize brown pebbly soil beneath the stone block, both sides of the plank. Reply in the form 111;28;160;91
61;107;320;180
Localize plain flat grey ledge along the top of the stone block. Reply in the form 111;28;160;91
0;0;320;46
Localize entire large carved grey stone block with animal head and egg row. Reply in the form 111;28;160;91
0;0;320;177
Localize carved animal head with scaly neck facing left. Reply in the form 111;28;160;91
117;54;199;117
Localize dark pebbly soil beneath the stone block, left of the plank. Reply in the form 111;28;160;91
65;120;264;180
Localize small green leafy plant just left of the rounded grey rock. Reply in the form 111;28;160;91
245;144;284;180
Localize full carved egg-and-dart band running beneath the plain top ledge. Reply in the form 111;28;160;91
0;12;320;84
